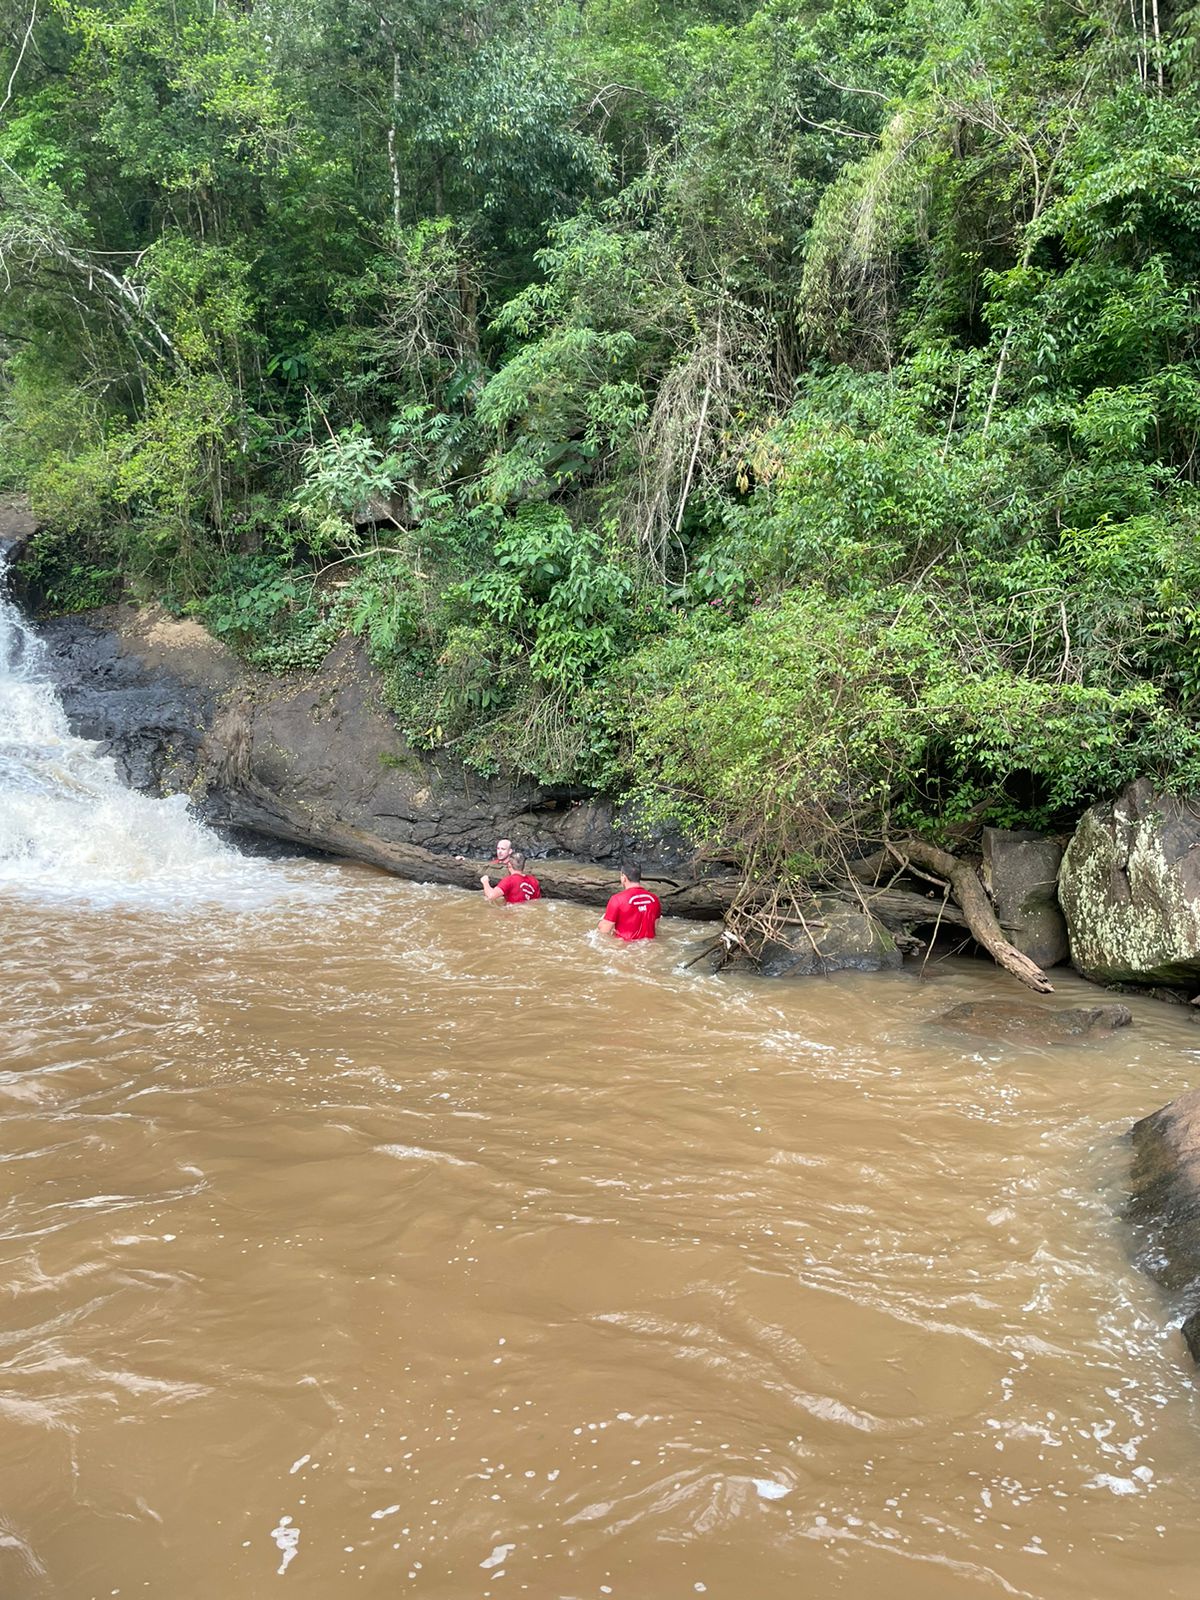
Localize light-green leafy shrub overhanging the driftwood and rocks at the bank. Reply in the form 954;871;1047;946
621;587;1200;872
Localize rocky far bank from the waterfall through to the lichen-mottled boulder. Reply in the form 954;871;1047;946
25;588;1200;998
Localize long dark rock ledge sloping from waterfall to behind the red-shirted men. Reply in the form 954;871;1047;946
32;606;733;917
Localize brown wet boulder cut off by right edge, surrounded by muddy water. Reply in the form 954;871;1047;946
1126;1090;1200;1362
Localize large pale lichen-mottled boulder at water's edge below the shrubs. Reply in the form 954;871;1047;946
1059;778;1200;986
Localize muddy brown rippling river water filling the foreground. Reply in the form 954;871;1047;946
0;864;1200;1600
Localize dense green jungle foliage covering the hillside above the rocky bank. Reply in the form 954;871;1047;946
0;0;1200;869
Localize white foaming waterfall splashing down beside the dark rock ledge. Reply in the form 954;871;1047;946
0;560;283;901
